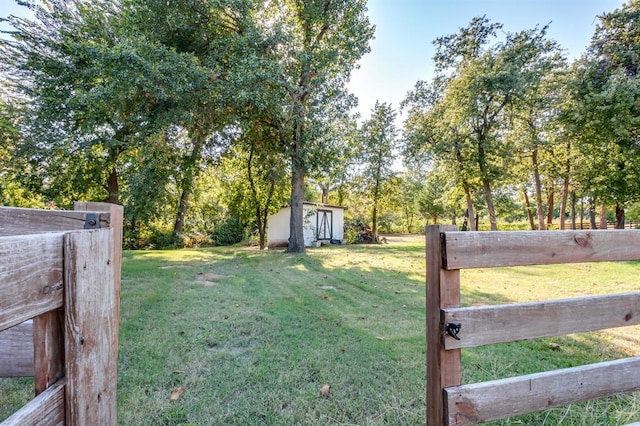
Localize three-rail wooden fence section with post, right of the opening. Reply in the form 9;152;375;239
426;226;640;425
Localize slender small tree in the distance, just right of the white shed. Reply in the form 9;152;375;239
360;101;398;235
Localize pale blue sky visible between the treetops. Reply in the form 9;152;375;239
349;0;624;118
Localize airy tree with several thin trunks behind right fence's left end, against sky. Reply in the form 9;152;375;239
409;17;557;230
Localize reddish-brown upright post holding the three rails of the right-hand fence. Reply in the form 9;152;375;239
426;226;462;425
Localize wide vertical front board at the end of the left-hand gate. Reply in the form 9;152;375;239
64;229;119;425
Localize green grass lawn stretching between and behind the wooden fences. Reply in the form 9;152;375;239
0;238;640;425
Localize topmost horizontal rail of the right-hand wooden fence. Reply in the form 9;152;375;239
443;230;640;270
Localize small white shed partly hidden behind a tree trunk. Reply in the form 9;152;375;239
267;201;346;247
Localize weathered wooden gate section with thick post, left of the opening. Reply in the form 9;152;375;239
0;203;122;426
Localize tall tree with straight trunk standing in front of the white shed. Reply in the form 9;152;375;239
265;0;373;252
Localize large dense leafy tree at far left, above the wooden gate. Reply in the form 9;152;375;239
2;0;229;218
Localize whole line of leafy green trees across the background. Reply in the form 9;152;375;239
0;0;640;251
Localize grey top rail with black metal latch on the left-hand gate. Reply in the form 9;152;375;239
0;207;110;236
